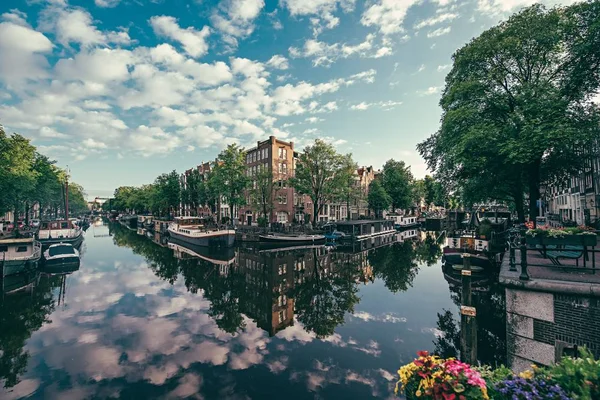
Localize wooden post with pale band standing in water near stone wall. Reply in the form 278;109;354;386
460;253;477;365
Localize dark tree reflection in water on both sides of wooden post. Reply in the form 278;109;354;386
434;283;506;365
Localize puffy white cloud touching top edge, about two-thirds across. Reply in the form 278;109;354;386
360;0;420;35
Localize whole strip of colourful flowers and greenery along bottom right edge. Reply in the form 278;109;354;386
396;349;600;400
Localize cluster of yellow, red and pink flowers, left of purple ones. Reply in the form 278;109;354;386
396;351;489;400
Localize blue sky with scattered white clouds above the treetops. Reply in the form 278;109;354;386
0;0;574;198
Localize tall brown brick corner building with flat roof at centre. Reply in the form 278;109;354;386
239;136;294;225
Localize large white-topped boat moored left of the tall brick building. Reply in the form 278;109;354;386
168;217;235;247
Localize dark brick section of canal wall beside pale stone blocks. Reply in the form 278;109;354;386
533;294;600;358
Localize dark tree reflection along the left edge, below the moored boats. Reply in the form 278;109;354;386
0;276;60;388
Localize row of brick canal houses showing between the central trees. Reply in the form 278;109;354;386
180;136;377;225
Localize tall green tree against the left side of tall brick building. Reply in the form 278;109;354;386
209;144;250;220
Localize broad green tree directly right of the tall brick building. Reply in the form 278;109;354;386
290;139;344;224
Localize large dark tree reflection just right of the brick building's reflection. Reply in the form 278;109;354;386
290;250;360;337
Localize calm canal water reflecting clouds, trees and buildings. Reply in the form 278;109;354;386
0;223;506;399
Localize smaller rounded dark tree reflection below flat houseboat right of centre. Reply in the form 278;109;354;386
369;241;419;293
